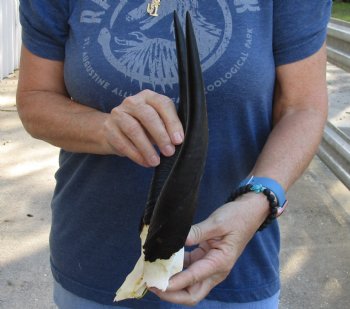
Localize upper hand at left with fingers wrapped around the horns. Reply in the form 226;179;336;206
104;90;184;167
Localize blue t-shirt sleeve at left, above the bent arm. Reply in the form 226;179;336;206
19;0;69;61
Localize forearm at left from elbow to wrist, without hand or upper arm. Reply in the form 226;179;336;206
17;91;108;154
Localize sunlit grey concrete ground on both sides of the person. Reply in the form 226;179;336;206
0;65;350;309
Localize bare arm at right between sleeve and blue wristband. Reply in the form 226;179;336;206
252;45;328;190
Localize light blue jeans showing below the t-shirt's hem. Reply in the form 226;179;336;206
54;281;280;309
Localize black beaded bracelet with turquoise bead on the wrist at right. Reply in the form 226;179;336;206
228;184;279;231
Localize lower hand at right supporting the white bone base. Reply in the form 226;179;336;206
150;193;269;306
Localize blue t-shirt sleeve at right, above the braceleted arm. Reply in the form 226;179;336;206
273;0;332;66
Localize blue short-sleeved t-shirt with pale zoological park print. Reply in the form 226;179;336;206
20;0;331;308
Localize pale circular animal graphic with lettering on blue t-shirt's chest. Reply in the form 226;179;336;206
80;0;260;97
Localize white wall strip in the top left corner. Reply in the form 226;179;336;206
0;0;21;79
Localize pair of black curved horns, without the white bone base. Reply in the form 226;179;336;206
141;12;208;262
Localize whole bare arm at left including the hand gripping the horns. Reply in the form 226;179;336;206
17;46;184;167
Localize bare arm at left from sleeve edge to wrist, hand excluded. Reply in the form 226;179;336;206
17;46;108;154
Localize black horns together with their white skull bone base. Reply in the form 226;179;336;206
115;12;208;301
